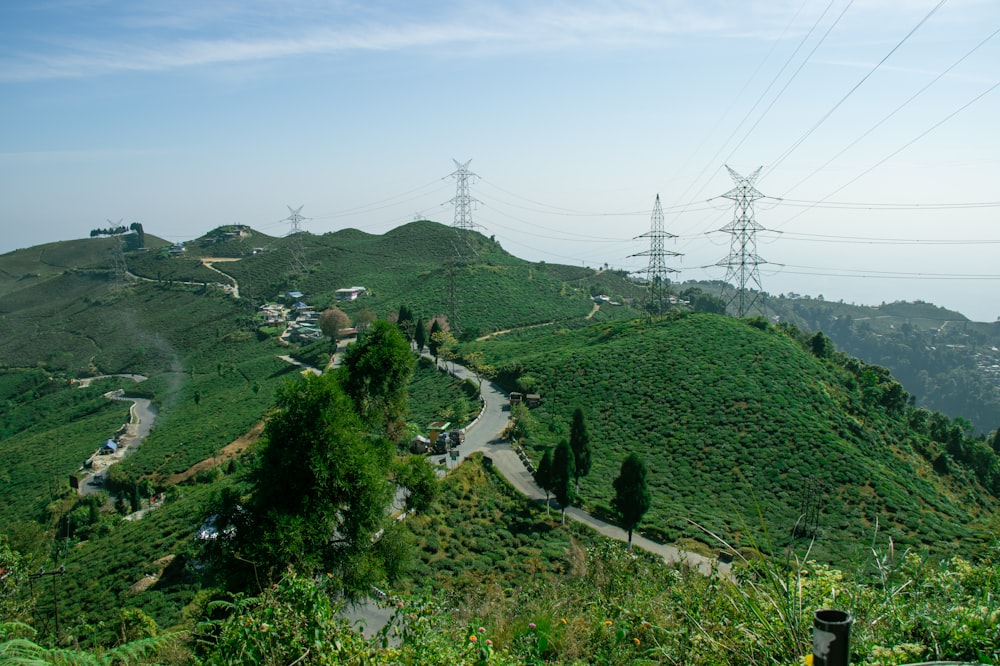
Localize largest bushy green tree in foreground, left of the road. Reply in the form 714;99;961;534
223;370;398;593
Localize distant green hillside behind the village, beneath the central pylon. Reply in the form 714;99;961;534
128;221;641;337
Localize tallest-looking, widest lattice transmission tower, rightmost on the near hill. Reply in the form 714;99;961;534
716;165;767;317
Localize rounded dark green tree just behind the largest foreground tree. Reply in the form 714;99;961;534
340;321;416;439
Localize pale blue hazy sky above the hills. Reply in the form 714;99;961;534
0;0;1000;321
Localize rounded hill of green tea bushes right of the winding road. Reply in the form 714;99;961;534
470;314;996;560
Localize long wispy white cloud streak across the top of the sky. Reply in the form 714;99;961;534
0;0;804;82
